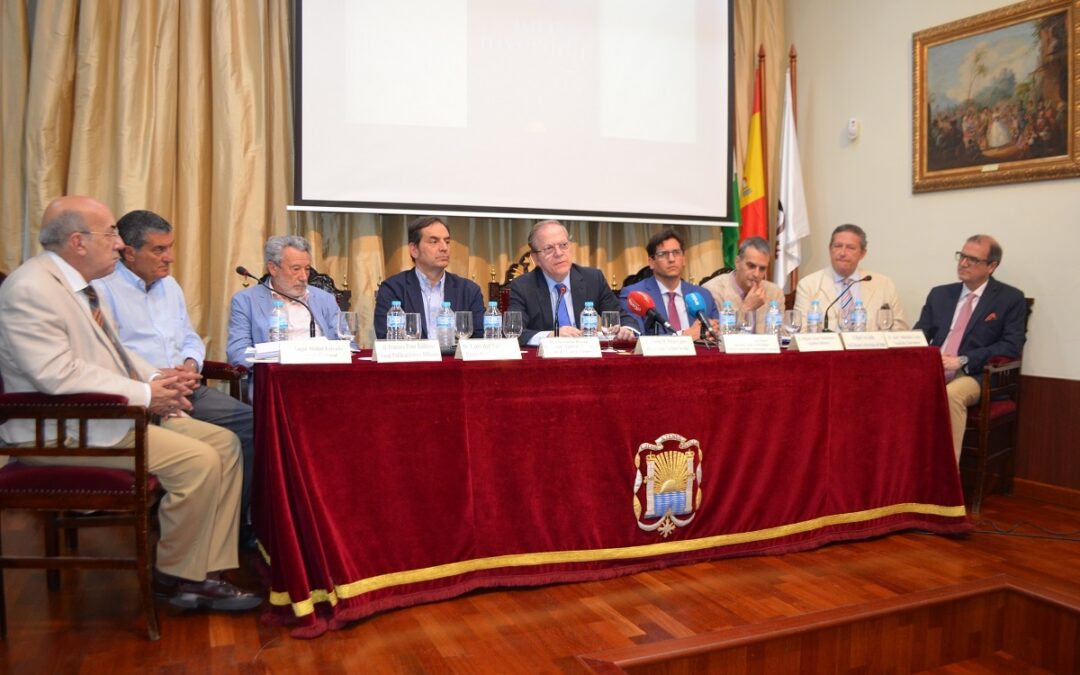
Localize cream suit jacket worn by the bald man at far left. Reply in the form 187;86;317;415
0;253;157;447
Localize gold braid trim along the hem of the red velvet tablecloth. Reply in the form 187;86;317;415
264;503;967;617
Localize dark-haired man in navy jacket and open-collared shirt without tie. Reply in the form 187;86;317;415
375;216;484;340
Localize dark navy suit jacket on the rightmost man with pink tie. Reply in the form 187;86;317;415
915;276;1027;376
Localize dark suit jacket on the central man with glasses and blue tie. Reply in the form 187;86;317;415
508;265;637;345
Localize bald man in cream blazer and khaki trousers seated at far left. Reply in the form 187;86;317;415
0;197;261;611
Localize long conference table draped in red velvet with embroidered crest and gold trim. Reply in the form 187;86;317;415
253;348;970;637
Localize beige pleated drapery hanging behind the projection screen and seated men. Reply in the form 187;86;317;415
0;0;787;359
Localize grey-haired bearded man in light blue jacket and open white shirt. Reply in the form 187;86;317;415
226;235;338;366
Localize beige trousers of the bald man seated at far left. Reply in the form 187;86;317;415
18;417;243;581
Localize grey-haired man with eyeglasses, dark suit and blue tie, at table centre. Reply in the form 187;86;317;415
509;220;636;347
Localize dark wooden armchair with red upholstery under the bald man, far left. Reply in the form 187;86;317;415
0;388;161;640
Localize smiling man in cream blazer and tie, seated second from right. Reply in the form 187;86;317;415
795;225;910;330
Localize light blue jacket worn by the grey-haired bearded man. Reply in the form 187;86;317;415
226;284;340;366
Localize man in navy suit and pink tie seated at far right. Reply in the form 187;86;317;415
915;234;1027;462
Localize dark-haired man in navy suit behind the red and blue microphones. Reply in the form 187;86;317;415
619;228;720;337
